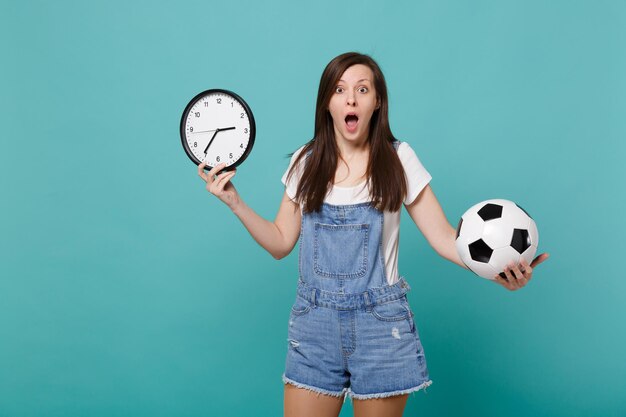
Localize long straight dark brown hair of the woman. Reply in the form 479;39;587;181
287;52;407;213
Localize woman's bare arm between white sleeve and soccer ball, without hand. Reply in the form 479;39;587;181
405;185;468;269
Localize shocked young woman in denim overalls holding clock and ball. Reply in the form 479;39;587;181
198;52;548;417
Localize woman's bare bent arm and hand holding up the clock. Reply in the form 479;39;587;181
198;163;301;259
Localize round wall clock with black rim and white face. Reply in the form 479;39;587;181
181;90;255;168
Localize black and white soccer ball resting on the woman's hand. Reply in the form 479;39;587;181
456;199;539;280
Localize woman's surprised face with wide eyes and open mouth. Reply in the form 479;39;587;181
328;64;378;142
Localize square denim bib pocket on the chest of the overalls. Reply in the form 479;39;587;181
313;223;370;279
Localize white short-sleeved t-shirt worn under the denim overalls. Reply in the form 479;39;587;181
281;142;432;285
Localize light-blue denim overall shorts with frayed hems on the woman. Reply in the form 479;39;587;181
282;146;432;400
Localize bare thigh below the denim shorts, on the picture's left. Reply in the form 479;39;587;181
284;384;343;417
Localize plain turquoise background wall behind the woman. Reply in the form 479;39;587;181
0;0;626;417
